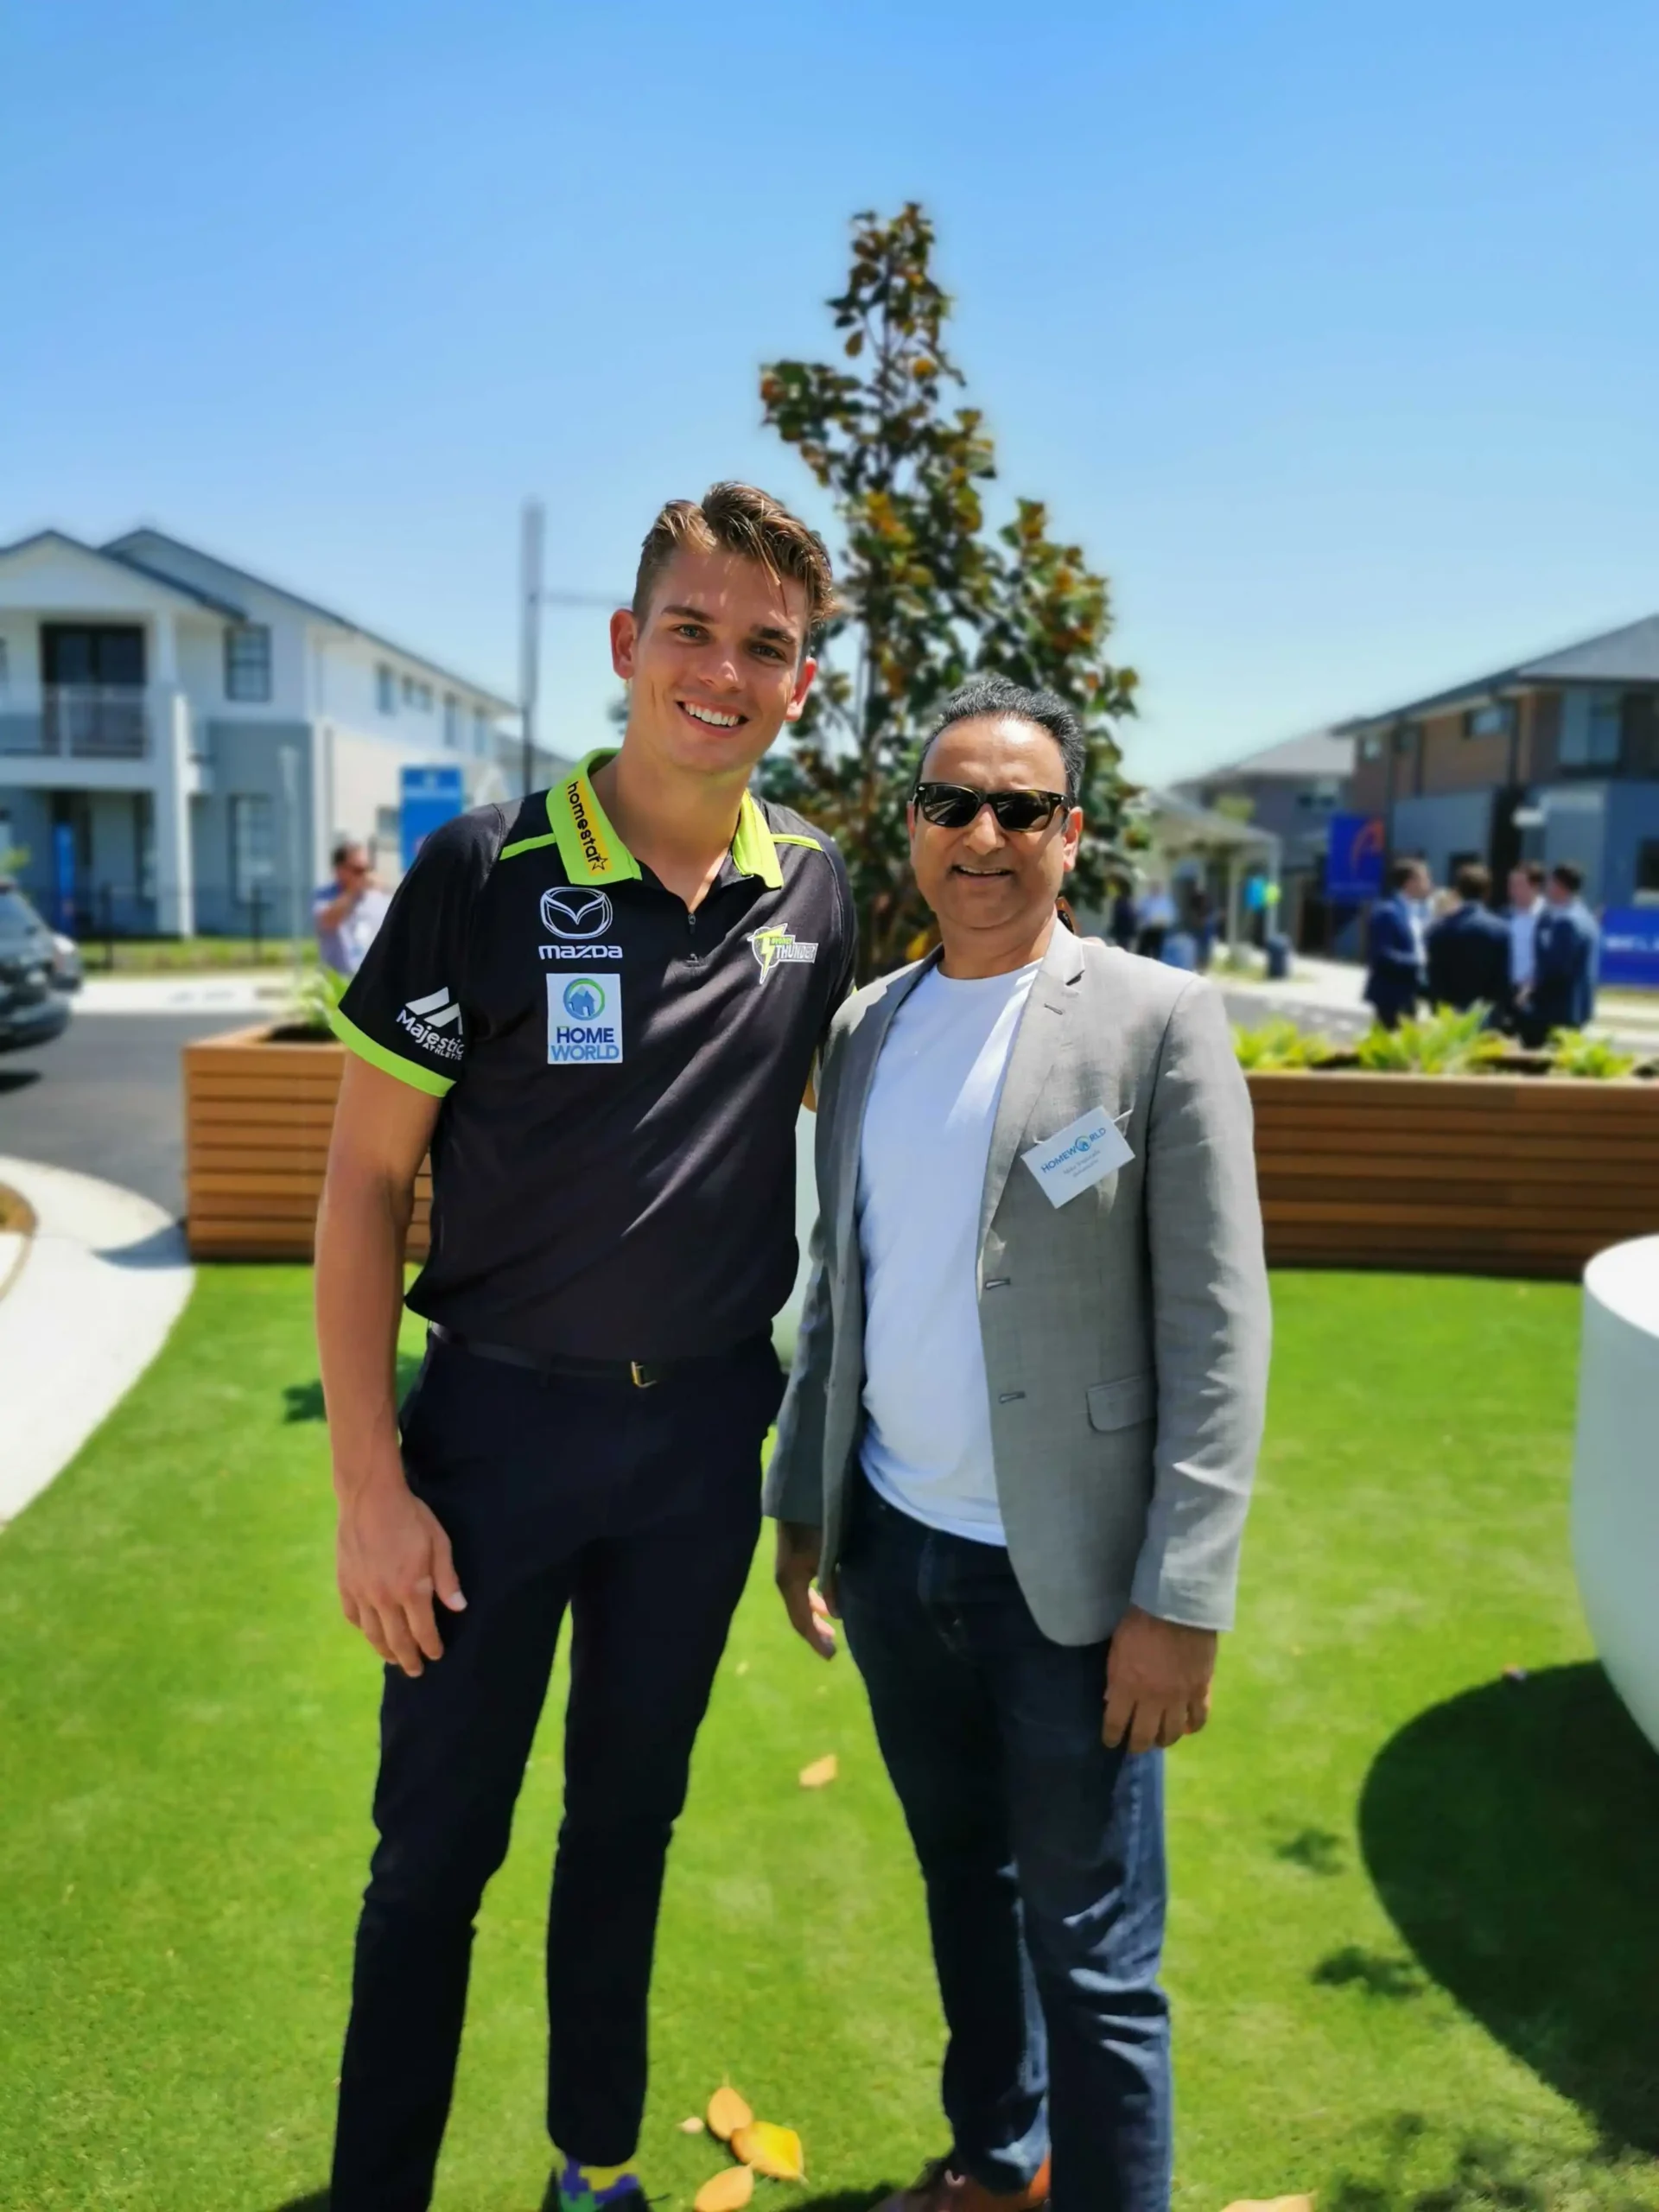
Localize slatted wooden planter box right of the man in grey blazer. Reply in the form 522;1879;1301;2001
1248;1071;1659;1279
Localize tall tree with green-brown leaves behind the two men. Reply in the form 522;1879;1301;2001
761;201;1135;976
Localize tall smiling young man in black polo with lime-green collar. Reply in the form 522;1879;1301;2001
316;485;854;2212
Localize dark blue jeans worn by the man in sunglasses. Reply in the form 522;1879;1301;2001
838;1484;1170;2212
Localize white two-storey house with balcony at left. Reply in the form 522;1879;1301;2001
0;529;515;936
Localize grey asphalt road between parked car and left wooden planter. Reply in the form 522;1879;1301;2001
0;1013;245;1219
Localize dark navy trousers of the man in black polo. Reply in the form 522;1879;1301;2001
329;1338;783;2212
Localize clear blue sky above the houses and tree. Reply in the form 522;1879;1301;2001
0;0;1659;781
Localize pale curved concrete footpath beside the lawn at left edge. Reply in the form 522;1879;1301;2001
0;1154;194;1526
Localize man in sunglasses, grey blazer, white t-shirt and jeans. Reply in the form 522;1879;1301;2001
767;679;1269;2212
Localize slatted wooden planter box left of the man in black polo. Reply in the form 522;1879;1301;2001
183;1022;431;1259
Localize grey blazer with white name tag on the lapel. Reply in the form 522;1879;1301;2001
766;927;1272;1643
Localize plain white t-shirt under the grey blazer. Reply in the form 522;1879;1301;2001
858;963;1042;1544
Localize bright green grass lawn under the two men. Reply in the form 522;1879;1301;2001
0;1268;1659;2212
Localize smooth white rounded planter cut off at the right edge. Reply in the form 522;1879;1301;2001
1573;1236;1659;1747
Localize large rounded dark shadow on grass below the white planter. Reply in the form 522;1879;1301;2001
1362;1666;1659;2150
